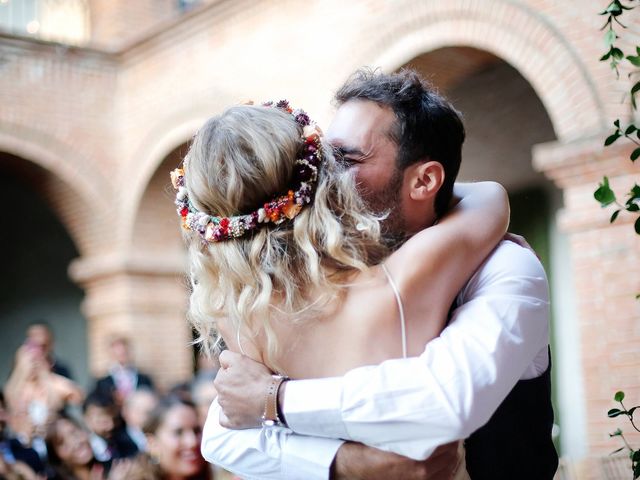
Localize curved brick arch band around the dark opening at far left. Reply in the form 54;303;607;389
0;125;110;254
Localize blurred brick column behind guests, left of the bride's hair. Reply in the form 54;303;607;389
70;253;193;389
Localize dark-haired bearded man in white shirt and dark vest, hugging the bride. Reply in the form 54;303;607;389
216;71;558;480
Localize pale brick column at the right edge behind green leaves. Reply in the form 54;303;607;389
534;133;640;480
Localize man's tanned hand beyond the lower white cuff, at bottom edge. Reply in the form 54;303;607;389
331;442;459;480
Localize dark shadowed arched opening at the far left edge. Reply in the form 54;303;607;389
0;152;89;387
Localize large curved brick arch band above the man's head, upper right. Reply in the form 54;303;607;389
356;0;606;141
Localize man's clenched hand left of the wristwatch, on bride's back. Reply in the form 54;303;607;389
214;350;271;429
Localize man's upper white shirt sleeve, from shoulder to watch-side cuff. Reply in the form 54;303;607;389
284;242;549;459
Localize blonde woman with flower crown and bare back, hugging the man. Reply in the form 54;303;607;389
172;101;509;478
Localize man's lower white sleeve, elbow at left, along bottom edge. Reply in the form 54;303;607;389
201;400;343;480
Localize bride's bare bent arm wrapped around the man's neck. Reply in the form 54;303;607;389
385;182;509;328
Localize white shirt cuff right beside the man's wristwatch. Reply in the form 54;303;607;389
283;377;349;439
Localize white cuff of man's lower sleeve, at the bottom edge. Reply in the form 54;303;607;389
282;435;344;480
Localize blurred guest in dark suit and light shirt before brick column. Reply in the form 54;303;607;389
95;336;154;406
